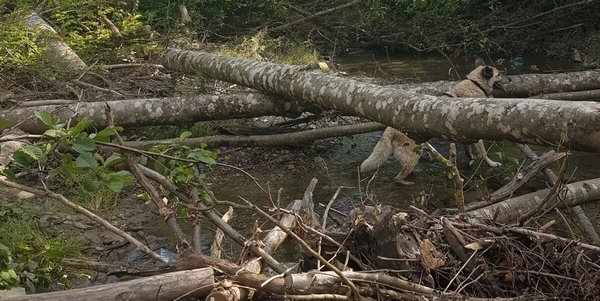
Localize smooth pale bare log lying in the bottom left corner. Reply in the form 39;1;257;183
2;268;215;301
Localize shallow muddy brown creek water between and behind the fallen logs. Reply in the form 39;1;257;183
147;55;600;260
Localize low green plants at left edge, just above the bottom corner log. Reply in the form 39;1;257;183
0;218;80;294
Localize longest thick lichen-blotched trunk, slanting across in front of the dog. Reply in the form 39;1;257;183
162;49;600;152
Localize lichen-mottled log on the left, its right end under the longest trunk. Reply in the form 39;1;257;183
0;92;315;134
